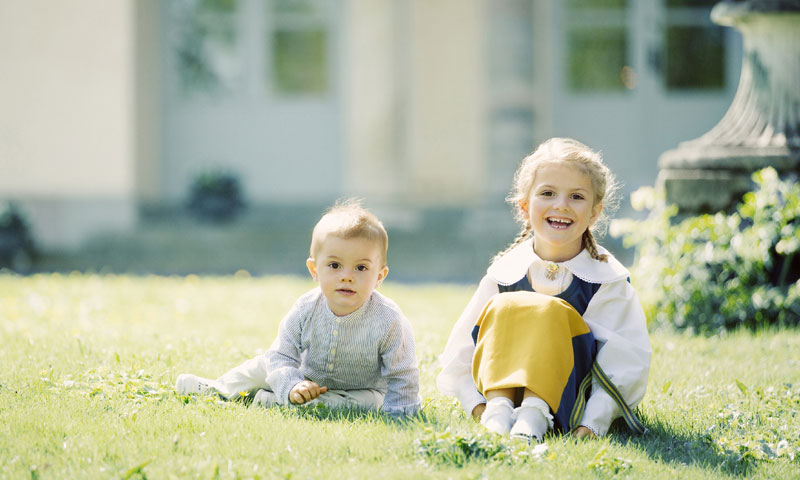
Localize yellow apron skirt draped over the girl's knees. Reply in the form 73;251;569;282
472;291;594;412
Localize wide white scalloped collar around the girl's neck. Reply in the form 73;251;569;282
486;238;630;285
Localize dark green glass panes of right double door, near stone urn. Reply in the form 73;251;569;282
563;0;726;93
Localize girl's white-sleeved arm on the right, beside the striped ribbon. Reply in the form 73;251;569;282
581;280;651;435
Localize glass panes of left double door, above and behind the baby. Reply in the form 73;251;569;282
164;0;337;96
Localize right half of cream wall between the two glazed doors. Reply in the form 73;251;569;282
406;0;485;206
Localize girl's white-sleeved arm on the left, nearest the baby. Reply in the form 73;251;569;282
436;277;498;418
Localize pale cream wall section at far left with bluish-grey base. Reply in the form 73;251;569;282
0;0;136;246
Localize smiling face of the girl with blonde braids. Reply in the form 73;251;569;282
519;163;603;262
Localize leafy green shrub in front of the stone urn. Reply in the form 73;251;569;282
611;168;800;334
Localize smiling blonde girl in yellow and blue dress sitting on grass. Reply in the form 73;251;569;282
437;138;651;440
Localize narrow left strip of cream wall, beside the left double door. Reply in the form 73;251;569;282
342;0;407;203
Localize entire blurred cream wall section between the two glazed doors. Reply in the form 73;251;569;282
345;0;485;207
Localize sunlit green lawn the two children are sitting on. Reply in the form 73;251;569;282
0;274;800;480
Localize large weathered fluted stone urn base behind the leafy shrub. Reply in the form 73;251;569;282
657;0;800;213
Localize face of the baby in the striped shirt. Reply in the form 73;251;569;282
306;235;389;317
